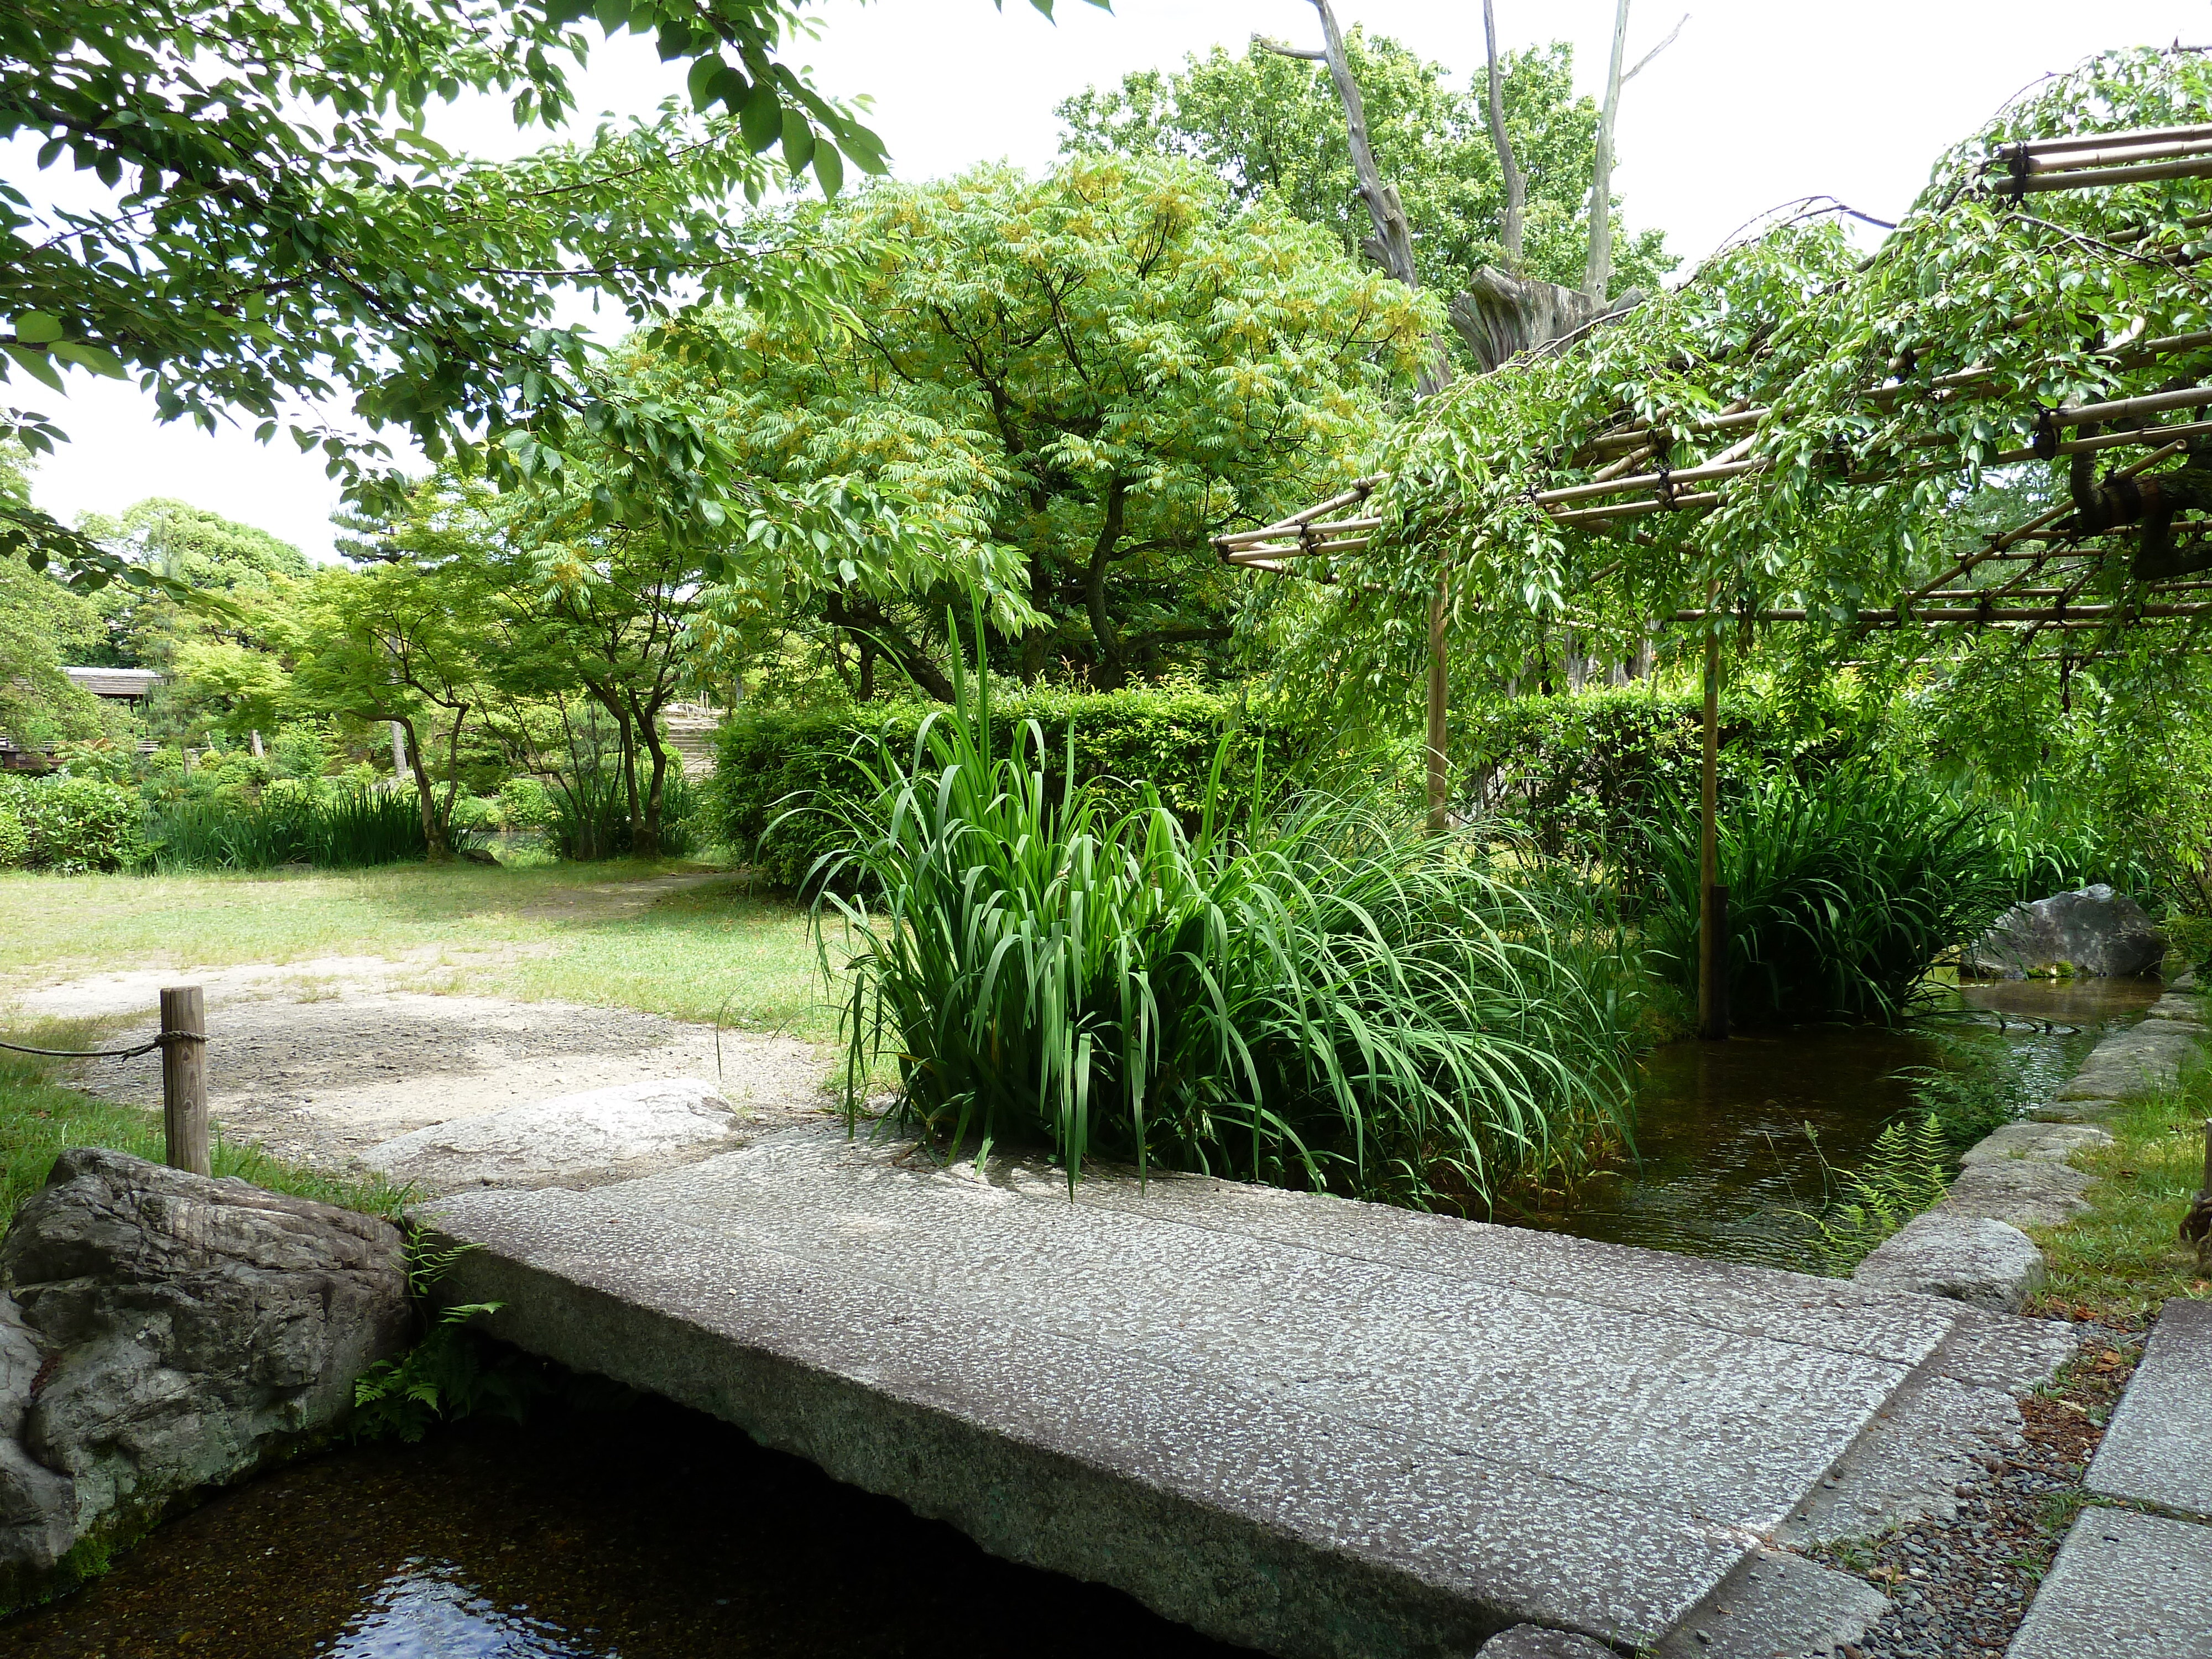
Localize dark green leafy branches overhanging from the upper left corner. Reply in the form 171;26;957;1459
0;0;938;586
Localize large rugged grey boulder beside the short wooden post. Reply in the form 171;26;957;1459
0;1148;409;1606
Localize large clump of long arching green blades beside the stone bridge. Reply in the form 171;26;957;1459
810;655;1628;1208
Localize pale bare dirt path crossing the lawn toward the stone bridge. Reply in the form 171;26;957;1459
9;876;827;1170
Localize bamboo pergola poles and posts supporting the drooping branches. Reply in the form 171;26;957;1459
1214;107;2212;1035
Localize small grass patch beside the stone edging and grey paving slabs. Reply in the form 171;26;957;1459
2033;1026;2212;1329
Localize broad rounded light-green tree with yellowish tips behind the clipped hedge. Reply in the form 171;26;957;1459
681;155;1436;692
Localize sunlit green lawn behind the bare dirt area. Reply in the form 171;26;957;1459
0;863;836;1040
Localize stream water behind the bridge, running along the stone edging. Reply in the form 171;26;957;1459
1524;980;2163;1272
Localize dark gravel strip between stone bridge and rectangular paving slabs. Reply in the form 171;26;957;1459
1809;1325;2143;1659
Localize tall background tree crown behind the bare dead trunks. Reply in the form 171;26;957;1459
1060;29;1674;314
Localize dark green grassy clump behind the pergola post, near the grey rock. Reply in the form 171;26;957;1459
1646;765;2013;1024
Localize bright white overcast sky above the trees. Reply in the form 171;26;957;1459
17;0;2212;557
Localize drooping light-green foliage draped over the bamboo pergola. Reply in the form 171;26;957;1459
1310;51;2212;726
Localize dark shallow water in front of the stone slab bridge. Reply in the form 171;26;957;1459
0;1402;1250;1659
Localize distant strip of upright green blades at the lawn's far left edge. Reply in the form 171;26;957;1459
148;790;429;872
